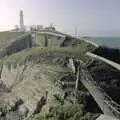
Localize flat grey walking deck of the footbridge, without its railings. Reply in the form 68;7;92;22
80;70;114;116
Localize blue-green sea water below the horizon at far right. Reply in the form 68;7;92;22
90;37;120;49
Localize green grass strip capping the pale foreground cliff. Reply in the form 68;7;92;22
0;47;89;66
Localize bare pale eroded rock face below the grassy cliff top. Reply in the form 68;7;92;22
0;53;70;120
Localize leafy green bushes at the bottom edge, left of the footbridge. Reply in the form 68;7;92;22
28;103;99;120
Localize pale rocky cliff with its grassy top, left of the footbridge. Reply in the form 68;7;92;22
0;47;100;120
